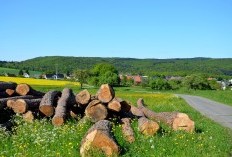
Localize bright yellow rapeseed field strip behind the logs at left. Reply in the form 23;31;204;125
0;76;80;86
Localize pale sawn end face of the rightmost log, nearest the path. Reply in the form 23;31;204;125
172;113;195;132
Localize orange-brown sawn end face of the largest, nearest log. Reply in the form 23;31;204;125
80;130;119;156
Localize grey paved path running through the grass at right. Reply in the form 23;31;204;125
176;94;232;129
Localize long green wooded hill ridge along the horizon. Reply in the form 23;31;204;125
0;56;232;76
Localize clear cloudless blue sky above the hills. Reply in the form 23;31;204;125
0;0;232;61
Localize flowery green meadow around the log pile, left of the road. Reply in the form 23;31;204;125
0;86;232;157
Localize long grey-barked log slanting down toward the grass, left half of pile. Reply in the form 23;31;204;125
52;88;75;126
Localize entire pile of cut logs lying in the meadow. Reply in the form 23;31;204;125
0;82;194;156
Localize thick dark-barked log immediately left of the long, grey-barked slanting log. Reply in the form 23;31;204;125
39;90;61;117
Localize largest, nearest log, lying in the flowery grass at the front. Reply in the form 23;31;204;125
80;120;119;157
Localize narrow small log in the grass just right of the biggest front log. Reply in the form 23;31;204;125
121;118;135;143
